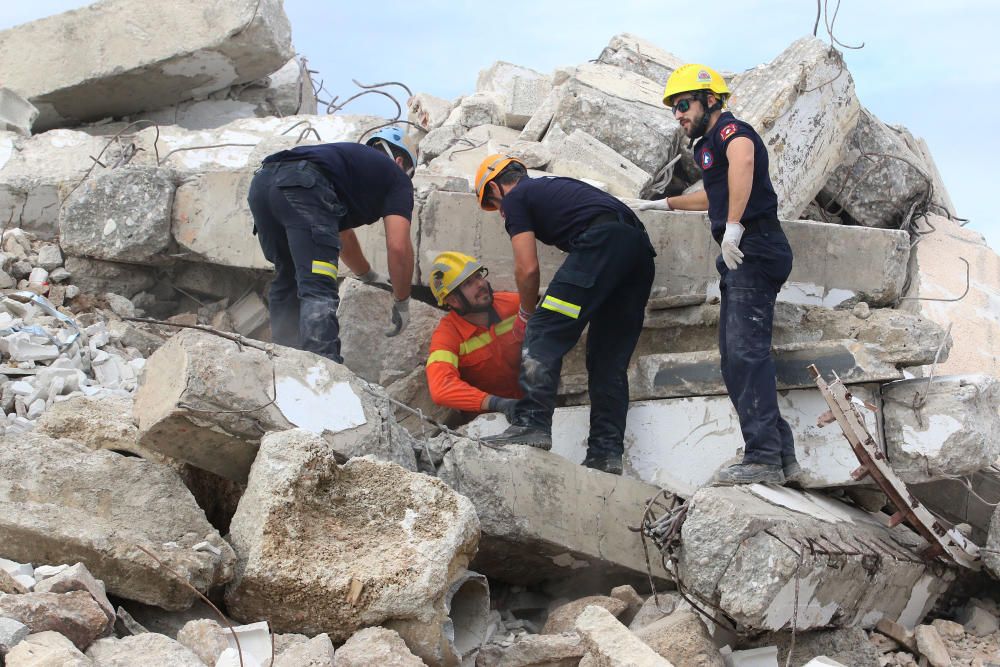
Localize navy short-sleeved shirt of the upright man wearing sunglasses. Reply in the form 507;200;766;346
694;111;778;240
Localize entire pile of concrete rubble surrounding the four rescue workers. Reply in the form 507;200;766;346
0;0;1000;667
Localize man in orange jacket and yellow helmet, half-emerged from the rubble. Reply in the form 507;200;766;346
427;252;524;419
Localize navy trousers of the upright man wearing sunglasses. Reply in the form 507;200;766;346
715;221;795;465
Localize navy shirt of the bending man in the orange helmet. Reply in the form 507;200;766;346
500;176;635;252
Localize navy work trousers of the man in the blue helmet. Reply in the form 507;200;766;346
247;160;347;363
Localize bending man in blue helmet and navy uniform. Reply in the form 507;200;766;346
247;127;415;363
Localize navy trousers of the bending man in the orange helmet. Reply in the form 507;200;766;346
513;218;656;458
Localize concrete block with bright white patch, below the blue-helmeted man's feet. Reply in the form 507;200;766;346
134;330;416;482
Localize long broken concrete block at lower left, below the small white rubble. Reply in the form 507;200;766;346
0;434;235;614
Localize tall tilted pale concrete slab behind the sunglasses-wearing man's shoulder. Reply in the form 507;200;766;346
729;37;861;219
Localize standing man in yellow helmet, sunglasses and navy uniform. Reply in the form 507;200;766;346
639;64;801;484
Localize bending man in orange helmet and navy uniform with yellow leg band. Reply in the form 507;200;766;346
475;155;656;474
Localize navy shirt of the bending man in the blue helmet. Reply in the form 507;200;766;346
264;142;413;229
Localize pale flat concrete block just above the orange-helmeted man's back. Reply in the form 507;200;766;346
548;130;652;198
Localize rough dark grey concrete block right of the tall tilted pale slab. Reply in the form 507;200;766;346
820;108;933;229
